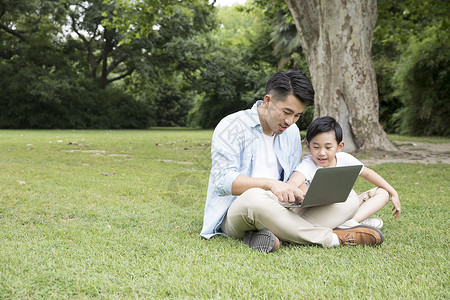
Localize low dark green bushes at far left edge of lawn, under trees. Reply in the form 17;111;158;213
0;68;150;129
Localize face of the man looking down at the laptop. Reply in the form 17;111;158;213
262;94;306;134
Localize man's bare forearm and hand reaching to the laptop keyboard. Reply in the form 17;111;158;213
231;175;304;203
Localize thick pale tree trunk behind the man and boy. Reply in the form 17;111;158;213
285;0;395;152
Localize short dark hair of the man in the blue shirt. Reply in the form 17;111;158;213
266;70;314;105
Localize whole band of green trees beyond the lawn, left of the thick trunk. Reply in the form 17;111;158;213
0;0;314;128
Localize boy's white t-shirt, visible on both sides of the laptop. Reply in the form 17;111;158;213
295;152;364;185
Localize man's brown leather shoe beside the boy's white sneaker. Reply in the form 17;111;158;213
333;225;384;246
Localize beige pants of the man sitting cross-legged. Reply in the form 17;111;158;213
222;188;359;247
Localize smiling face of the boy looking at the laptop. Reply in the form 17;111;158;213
306;130;344;168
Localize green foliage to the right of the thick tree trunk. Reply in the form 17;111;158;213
372;0;450;135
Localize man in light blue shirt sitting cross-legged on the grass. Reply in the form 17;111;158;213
201;71;383;253
